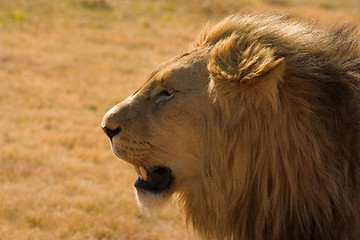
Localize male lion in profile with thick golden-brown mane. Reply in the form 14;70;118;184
102;14;360;240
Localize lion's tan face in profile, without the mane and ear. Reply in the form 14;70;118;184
102;49;210;208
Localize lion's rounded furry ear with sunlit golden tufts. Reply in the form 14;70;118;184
208;34;285;107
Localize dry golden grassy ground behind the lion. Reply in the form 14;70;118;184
0;0;360;240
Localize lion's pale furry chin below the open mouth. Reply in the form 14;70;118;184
135;188;172;215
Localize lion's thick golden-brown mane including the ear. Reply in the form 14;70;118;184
179;15;360;240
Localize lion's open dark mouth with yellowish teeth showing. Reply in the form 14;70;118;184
134;166;172;194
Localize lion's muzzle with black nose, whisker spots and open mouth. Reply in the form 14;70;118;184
101;99;173;194
